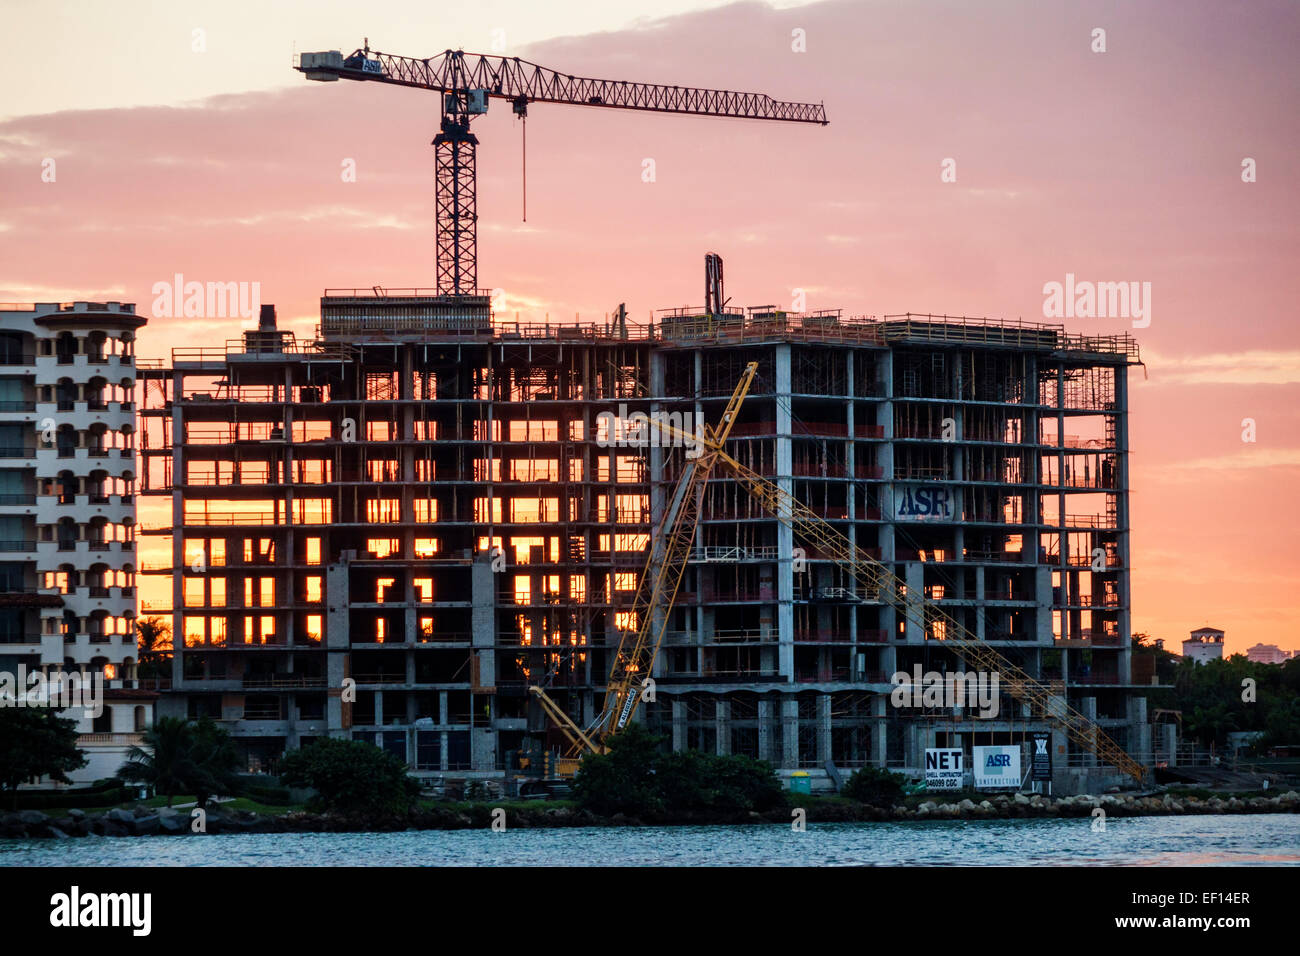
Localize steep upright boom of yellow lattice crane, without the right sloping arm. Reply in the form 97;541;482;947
528;362;758;754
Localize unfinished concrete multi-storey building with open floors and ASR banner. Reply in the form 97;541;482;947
140;274;1152;791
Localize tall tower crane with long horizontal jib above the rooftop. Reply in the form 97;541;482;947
295;40;827;295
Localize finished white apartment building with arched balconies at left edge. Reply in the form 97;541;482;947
0;302;156;782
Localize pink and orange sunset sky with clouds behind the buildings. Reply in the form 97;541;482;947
0;0;1300;653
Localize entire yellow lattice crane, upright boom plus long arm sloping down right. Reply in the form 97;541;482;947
532;363;1147;786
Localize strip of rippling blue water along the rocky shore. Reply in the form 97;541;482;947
0;814;1300;866
